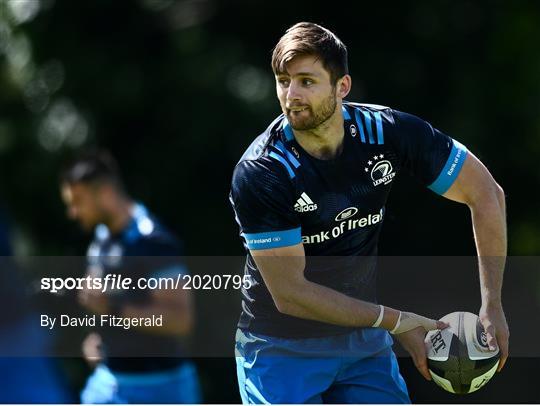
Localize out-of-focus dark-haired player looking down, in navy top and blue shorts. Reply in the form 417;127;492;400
60;151;200;403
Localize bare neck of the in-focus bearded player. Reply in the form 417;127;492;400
293;103;344;160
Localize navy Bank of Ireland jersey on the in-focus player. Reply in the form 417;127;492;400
230;102;467;337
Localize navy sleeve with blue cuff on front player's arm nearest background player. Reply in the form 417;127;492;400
230;158;302;250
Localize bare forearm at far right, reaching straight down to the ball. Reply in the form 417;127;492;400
470;188;507;306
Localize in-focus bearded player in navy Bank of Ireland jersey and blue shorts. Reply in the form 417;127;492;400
231;23;509;403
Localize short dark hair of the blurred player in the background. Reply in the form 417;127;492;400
60;150;124;192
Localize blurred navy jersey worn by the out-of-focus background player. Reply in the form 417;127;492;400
87;204;186;372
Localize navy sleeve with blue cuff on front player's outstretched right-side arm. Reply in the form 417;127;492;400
391;111;467;195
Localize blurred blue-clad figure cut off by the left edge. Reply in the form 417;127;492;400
0;207;74;403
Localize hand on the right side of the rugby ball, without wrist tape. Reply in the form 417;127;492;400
479;304;510;372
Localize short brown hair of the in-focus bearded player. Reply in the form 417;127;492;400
272;22;349;84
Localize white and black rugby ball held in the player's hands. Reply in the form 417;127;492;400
425;312;500;394
